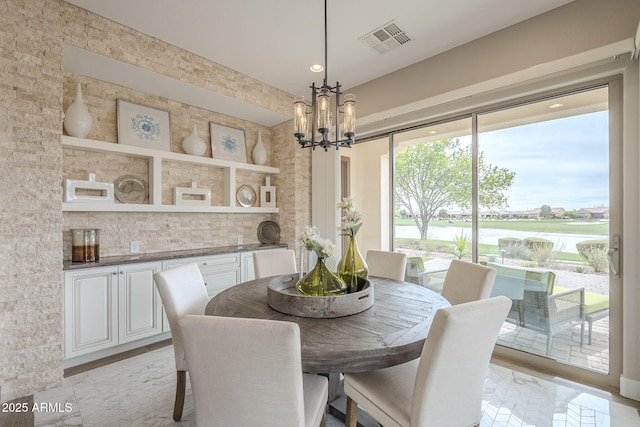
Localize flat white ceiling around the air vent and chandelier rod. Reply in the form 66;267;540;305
66;0;572;95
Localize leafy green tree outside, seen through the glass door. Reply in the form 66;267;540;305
395;138;515;240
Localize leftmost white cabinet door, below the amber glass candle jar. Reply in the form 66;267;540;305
64;267;118;359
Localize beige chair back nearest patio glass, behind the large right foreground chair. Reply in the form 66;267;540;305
442;259;496;305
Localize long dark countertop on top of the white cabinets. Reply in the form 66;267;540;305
63;243;287;271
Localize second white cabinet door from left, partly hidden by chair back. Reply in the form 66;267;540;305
118;262;162;343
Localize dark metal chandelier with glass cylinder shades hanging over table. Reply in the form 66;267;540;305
293;0;356;151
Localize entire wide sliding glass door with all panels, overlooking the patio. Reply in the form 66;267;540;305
343;79;621;384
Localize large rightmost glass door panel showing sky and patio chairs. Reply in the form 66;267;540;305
477;85;615;374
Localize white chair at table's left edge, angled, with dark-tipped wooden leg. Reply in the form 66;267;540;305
154;263;209;421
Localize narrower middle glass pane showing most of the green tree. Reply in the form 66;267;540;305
393;117;472;291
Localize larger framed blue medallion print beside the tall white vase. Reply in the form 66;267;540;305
117;99;171;151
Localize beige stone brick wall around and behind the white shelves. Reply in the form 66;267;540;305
0;0;310;401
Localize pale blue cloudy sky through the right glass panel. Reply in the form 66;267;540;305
472;111;609;210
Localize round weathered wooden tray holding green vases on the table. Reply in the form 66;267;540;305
267;274;373;318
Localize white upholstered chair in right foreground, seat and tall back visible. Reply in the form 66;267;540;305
344;296;511;427
